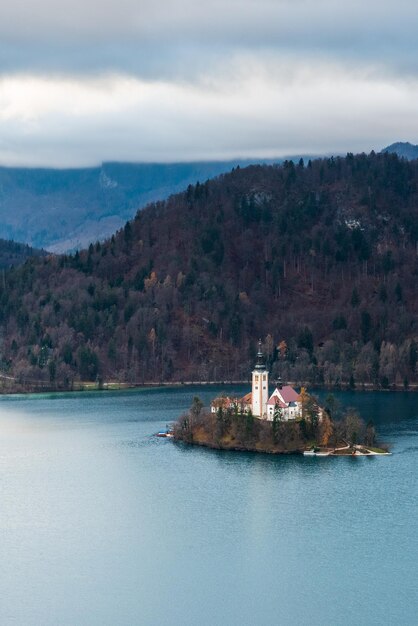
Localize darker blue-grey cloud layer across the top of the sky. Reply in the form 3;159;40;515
0;0;418;77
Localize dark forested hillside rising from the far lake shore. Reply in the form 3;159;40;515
0;153;418;387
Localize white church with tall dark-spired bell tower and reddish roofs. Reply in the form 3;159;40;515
211;341;302;421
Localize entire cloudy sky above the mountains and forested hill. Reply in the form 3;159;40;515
0;0;418;167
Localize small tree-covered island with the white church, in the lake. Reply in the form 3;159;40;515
169;341;389;456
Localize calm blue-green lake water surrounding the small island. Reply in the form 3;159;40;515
0;387;418;626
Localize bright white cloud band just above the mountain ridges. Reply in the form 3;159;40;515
0;55;418;166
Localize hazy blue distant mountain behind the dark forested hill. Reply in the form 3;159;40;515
0;160;316;252
